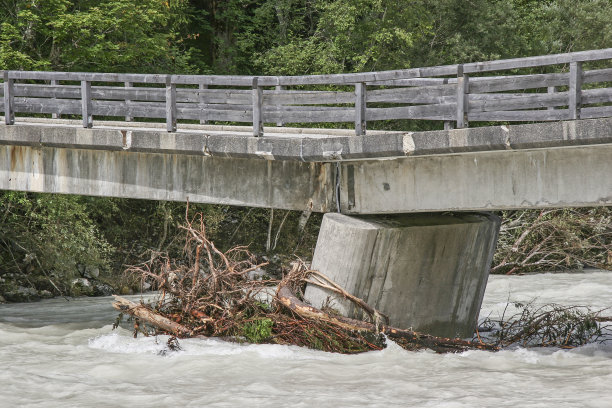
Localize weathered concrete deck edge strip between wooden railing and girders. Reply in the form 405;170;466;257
0;118;612;162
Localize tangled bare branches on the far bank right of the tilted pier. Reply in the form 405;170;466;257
491;207;612;275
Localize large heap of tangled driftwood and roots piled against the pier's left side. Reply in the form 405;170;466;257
114;214;495;353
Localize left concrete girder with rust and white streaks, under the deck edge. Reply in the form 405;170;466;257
0;145;336;212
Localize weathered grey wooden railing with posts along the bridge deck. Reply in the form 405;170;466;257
0;48;612;136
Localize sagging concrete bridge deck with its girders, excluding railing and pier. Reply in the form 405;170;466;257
0;118;612;214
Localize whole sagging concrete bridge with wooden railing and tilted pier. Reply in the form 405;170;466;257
0;49;612;335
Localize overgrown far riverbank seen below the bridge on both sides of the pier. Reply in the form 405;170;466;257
0;202;612;302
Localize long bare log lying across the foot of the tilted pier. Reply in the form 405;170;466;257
276;285;498;352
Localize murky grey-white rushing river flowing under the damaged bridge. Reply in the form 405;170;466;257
0;271;612;408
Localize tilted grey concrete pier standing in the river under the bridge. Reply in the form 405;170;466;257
305;213;500;337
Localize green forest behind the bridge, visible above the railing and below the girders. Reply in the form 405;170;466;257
0;0;612;302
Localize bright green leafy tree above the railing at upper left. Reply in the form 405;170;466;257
0;0;203;73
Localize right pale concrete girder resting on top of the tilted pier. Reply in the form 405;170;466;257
340;144;612;214
